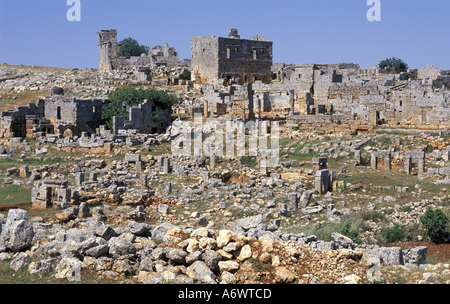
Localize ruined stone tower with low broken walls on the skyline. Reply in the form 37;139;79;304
97;29;178;72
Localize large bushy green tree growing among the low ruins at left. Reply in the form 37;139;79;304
102;87;178;129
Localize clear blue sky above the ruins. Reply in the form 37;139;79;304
0;0;450;69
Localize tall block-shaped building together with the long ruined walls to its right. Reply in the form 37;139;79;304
191;29;450;134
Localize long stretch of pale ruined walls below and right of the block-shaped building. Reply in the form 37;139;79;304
199;59;450;133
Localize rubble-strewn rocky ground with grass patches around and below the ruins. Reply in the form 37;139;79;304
0;66;450;284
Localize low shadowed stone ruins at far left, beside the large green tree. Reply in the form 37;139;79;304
0;96;171;141
